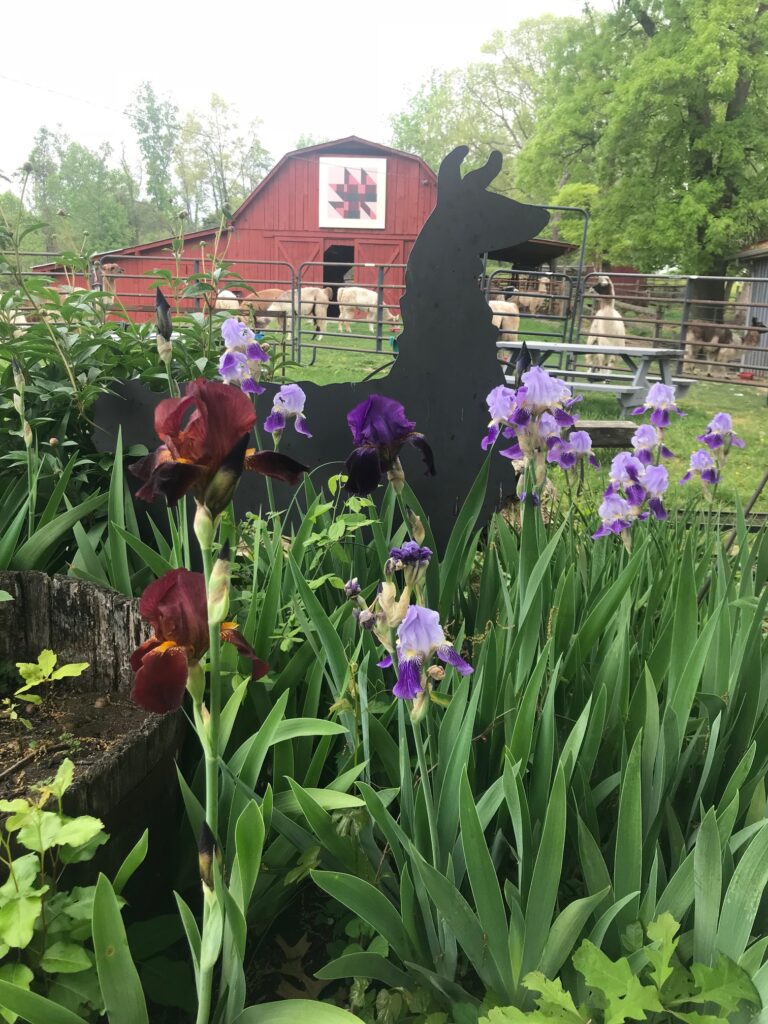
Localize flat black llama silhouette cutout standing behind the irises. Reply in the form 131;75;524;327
96;145;549;547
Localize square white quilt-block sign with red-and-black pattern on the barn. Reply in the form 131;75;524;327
318;157;387;228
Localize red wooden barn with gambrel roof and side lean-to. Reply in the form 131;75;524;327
52;135;437;319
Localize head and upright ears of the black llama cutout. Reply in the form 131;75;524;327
425;145;549;270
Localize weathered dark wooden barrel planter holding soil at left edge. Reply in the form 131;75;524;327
0;572;183;884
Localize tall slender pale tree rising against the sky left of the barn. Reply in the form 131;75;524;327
128;82;180;224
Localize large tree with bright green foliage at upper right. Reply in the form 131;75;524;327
517;0;768;297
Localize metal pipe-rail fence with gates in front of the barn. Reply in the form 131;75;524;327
0;251;768;387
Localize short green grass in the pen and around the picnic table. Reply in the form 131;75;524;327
270;318;768;512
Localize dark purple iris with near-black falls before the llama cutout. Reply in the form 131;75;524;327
345;394;435;498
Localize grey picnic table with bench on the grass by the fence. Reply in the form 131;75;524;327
496;340;695;412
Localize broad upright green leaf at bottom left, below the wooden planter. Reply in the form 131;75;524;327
93;874;150;1024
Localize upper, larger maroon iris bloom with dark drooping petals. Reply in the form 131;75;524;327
131;379;306;518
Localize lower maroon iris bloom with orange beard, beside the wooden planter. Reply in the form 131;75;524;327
131;569;269;715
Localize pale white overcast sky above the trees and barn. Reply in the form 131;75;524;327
0;0;604;185
